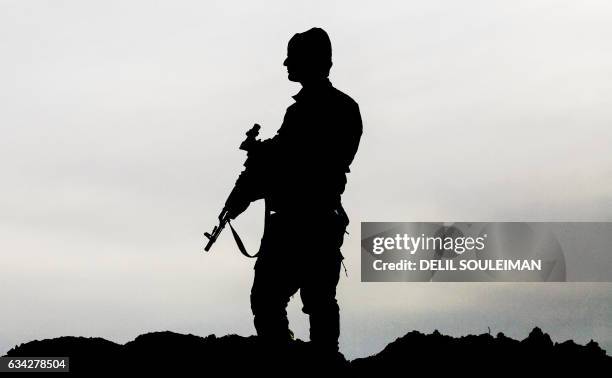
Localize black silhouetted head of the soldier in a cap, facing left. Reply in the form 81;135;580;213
283;28;332;84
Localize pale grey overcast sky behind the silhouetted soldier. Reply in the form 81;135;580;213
0;0;612;358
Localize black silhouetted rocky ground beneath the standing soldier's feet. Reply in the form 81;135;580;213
7;328;612;376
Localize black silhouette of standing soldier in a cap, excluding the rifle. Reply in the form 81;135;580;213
225;28;362;351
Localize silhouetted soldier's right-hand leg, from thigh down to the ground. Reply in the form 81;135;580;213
300;253;342;352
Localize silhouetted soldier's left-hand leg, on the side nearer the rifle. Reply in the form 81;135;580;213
251;251;298;343
